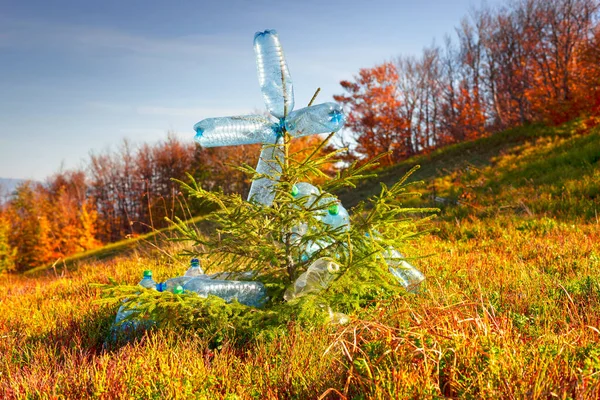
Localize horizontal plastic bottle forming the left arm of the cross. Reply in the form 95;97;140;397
194;115;277;147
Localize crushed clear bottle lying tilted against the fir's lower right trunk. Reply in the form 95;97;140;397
283;258;340;301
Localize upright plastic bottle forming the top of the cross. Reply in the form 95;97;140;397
254;30;294;118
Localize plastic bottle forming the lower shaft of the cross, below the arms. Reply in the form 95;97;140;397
248;138;284;206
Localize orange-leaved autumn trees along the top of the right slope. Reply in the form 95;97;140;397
335;0;600;164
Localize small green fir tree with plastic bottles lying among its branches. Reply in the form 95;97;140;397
99;117;434;339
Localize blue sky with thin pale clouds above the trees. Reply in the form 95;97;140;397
0;0;496;180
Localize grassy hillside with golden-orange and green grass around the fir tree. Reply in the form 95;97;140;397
0;122;600;399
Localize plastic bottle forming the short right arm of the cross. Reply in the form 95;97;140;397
285;103;346;137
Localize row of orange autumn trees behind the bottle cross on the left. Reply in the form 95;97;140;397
0;134;260;272
